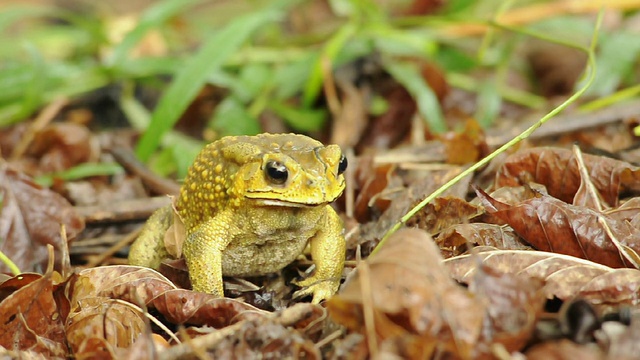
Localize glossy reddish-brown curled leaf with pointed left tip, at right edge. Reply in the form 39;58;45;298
476;189;640;267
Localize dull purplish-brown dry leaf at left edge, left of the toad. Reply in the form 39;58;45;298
0;162;84;272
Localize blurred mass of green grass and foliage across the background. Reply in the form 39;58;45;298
0;0;640;174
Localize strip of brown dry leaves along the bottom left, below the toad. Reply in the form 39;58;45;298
0;260;325;359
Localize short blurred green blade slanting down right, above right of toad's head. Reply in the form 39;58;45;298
384;59;447;133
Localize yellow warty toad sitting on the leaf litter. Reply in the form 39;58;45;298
129;134;347;303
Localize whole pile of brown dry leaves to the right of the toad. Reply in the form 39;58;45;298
336;148;640;359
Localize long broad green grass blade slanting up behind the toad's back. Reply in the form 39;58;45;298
136;10;280;161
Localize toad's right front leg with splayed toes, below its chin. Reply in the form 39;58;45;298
294;205;346;304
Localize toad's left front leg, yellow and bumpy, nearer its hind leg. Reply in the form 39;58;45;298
182;213;231;297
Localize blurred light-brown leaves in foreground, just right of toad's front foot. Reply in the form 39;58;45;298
327;229;544;359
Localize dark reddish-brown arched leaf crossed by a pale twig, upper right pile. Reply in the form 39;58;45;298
495;148;640;206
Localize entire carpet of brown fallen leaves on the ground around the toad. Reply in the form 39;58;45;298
0;131;640;359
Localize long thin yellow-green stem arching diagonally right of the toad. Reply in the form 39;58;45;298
371;11;603;255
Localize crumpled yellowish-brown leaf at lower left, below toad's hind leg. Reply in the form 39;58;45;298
65;265;175;358
